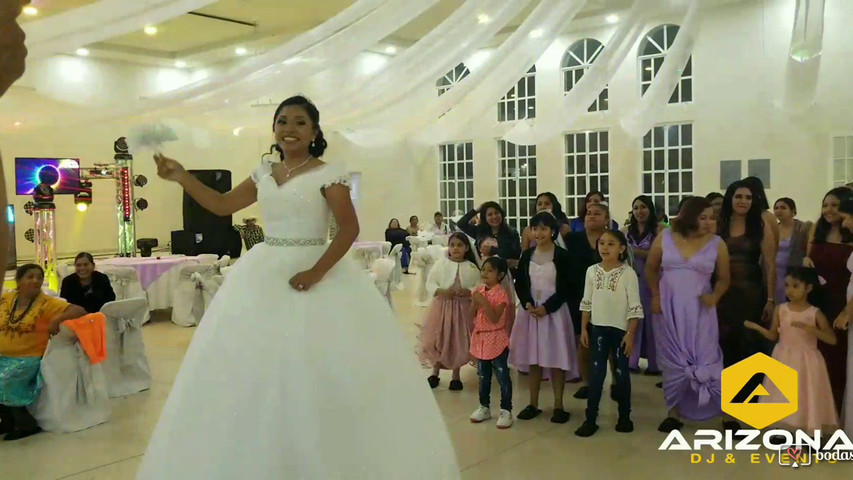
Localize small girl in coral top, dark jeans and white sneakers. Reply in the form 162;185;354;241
471;257;512;429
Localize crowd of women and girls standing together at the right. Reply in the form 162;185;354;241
410;177;853;436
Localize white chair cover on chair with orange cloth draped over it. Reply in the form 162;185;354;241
28;325;110;433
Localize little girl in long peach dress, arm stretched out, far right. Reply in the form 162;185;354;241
744;267;838;431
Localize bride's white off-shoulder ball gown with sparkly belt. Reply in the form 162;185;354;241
137;159;460;480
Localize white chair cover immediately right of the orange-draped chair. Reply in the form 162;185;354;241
101;298;151;398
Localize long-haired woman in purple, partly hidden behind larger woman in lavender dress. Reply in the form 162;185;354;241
625;195;664;375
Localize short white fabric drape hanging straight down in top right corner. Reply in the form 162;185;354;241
782;0;826;115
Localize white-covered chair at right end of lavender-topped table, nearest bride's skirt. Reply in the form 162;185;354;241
172;265;222;327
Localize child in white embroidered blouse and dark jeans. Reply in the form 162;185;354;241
575;230;643;437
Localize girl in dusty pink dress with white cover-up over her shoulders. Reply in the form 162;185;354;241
418;232;480;391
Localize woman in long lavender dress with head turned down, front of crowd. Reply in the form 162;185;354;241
646;197;729;433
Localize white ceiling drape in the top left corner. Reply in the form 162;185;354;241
23;0;216;61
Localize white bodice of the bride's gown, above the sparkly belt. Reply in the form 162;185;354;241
252;159;350;239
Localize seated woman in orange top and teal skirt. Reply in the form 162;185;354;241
0;264;86;441
